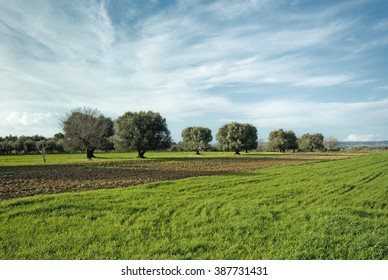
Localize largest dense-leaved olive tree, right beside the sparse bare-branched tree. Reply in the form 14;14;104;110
114;111;172;158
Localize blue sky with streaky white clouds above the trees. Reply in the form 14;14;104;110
0;0;388;141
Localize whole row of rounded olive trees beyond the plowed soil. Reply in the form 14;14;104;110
0;108;334;159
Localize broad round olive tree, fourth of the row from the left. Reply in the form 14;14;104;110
216;122;257;155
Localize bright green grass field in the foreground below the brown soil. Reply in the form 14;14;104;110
0;153;388;260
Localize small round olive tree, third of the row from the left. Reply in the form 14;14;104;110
182;127;213;155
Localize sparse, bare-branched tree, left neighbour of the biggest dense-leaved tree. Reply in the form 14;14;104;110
61;107;114;159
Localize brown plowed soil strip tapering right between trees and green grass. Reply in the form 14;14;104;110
0;154;356;200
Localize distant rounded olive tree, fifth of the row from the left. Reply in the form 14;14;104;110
268;129;298;153
